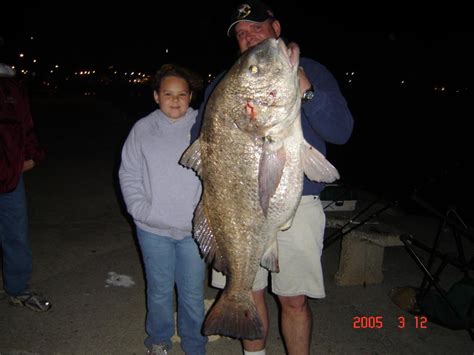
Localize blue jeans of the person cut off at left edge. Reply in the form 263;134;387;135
0;177;33;296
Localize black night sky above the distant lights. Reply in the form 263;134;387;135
0;1;474;81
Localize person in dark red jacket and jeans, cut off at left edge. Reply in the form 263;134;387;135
0;38;51;312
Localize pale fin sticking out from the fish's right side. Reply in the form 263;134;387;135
301;142;339;182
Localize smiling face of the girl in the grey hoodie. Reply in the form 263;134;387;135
153;76;192;119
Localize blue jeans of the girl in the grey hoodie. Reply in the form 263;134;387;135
137;228;207;355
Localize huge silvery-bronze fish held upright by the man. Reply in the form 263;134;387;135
180;39;339;339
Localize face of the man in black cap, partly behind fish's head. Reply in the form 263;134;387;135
235;19;281;53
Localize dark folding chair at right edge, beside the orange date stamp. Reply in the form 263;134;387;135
400;193;474;340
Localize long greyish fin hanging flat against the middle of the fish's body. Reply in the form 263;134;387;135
258;142;286;217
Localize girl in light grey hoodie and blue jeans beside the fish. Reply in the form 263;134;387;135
119;64;207;355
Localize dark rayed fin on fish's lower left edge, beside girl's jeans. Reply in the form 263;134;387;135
193;200;227;274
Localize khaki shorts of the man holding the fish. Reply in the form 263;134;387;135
211;196;326;298
